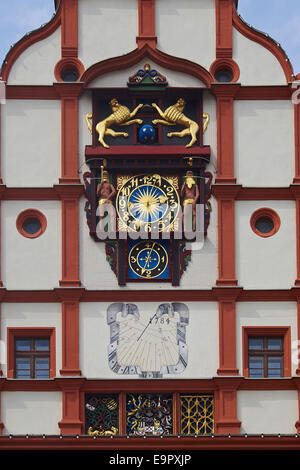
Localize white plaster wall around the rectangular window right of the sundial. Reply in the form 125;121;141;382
236;302;298;375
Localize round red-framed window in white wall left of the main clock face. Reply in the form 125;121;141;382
16;209;47;238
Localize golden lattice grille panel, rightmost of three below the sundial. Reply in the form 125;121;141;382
180;394;214;435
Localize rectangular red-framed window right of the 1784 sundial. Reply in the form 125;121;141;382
243;327;291;379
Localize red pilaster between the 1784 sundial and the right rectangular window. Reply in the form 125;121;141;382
213;288;242;375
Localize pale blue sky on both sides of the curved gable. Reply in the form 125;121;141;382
0;0;300;74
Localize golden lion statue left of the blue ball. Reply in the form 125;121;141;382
86;98;143;148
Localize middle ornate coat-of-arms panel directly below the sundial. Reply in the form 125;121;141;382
126;393;173;436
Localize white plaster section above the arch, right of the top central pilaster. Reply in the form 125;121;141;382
155;0;216;70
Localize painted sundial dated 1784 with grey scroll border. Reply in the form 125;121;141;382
107;303;189;378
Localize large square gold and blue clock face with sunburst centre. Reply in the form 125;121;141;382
116;174;180;232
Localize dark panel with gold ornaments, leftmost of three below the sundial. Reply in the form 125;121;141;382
85;394;119;436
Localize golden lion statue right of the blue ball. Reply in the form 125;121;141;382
152;98;209;147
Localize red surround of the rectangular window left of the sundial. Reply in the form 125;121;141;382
7;327;56;379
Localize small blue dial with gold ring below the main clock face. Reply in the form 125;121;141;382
128;240;169;279
